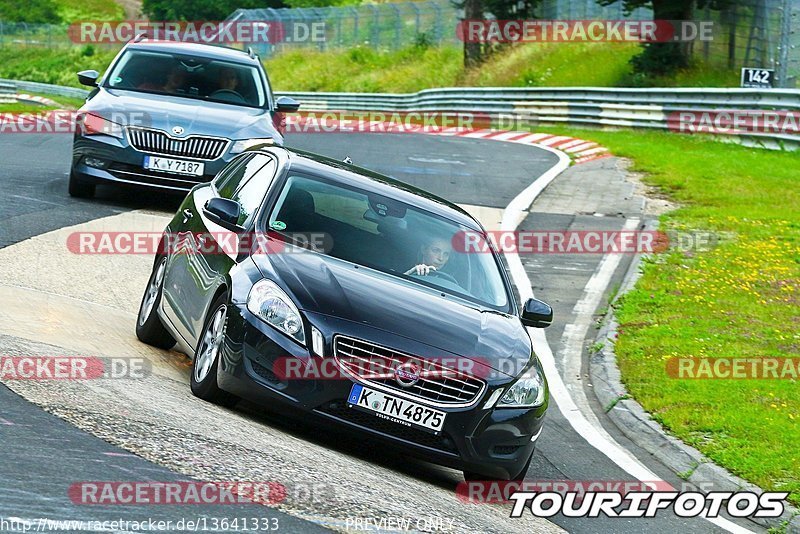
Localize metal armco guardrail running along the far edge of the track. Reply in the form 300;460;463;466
0;79;800;150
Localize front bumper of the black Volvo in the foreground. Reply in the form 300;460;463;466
218;304;547;479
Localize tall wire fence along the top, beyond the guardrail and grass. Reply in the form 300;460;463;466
0;0;800;87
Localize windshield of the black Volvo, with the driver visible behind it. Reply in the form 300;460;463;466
268;174;509;311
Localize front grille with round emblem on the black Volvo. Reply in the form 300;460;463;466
333;336;486;407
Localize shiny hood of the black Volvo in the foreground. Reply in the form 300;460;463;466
253;252;531;375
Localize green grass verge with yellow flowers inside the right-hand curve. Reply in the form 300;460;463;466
532;128;800;505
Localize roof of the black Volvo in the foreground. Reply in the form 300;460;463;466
269;147;483;230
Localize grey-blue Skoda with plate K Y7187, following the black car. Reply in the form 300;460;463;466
69;38;299;197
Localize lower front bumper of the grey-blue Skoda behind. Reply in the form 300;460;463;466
72;134;235;193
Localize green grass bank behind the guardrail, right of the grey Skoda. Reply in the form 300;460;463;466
265;43;739;93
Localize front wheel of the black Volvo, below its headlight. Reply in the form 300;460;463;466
190;295;239;407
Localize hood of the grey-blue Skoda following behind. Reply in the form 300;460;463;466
81;88;282;141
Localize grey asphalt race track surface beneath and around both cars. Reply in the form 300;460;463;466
0;134;759;533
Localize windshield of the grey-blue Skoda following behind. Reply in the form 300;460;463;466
106;50;266;107
